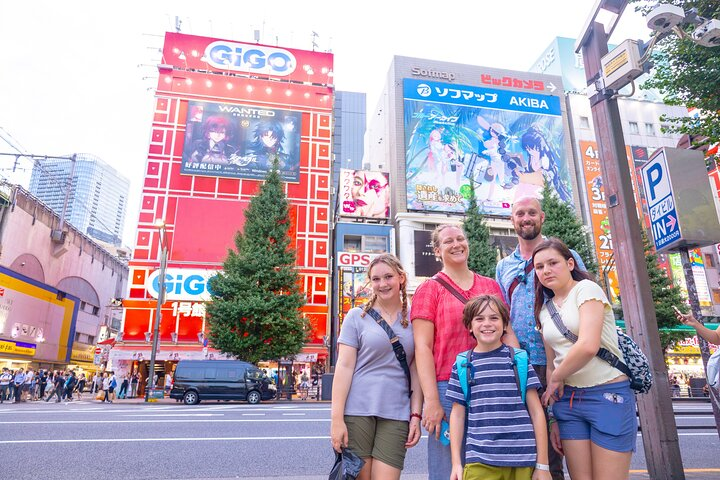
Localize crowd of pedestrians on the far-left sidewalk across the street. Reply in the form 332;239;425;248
0;367;149;403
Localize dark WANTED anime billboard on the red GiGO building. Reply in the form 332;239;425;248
180;100;302;182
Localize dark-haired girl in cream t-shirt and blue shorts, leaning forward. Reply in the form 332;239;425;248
533;238;637;480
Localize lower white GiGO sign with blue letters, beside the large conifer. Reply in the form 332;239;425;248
145;268;218;302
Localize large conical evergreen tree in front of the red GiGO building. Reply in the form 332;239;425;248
205;160;309;363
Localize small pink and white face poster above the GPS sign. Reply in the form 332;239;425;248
338;168;390;218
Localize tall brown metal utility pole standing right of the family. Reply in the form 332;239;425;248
576;5;685;480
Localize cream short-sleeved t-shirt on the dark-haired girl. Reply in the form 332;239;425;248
540;280;623;387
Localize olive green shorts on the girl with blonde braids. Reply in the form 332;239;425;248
345;415;410;470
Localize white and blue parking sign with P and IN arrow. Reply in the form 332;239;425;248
641;152;682;251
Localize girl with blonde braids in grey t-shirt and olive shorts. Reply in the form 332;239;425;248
330;254;422;480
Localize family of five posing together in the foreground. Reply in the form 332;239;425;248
330;197;668;480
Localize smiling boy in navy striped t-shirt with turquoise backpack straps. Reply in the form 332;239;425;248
446;295;552;480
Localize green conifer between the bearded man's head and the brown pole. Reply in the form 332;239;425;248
540;182;597;274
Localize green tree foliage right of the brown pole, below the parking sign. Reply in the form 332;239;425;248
640;228;686;352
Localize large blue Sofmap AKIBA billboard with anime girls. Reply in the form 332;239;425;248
403;78;572;216
